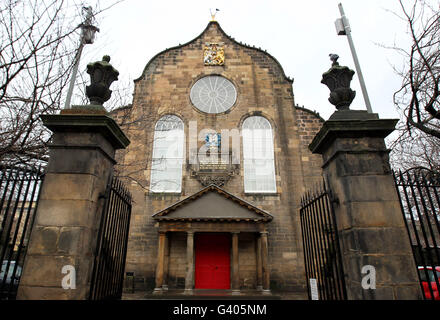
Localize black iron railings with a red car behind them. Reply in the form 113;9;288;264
394;168;440;300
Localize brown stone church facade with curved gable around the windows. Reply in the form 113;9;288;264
113;21;324;294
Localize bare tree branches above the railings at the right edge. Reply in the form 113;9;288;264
388;0;440;171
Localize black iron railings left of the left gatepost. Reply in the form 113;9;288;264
0;167;44;299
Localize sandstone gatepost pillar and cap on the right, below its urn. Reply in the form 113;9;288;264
309;110;421;300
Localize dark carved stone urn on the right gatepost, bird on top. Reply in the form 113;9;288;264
321;54;356;110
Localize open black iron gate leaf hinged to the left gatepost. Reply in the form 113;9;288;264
89;177;131;300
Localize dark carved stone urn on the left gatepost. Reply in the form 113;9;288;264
86;55;119;105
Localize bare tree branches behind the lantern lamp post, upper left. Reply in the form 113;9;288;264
0;0;125;169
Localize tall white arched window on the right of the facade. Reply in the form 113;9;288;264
242;116;277;193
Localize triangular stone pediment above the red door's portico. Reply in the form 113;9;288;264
153;185;273;222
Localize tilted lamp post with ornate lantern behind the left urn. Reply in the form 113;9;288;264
64;7;99;109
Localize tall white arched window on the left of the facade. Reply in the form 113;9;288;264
150;115;184;192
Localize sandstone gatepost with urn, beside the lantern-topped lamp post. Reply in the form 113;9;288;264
17;57;129;300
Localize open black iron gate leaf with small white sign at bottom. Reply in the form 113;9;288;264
300;184;347;300
